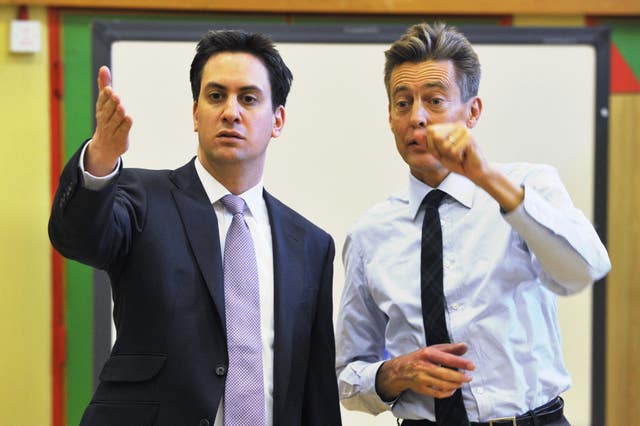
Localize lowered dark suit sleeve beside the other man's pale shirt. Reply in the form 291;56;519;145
303;237;342;426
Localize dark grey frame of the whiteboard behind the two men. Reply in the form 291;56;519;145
92;20;610;424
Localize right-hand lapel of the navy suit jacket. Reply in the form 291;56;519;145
264;191;305;416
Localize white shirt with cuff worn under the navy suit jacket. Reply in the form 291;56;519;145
79;144;274;426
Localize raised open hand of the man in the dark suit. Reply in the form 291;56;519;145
84;66;133;176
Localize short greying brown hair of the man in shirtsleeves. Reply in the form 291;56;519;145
384;22;480;102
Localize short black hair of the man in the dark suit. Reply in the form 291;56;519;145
189;30;293;111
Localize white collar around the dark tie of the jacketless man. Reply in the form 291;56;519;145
409;172;475;218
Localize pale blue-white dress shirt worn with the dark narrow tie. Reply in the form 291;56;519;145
336;164;611;422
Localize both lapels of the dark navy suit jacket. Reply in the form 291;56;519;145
170;171;306;414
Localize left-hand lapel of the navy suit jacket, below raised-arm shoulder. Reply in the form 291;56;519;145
169;160;227;334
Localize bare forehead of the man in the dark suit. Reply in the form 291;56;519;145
202;52;270;90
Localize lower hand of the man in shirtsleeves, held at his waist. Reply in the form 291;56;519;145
376;343;475;400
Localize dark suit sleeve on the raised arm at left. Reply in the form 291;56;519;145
49;141;146;269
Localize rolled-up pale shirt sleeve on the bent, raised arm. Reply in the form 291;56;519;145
504;166;611;295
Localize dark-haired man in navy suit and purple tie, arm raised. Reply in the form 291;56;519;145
49;31;340;426
